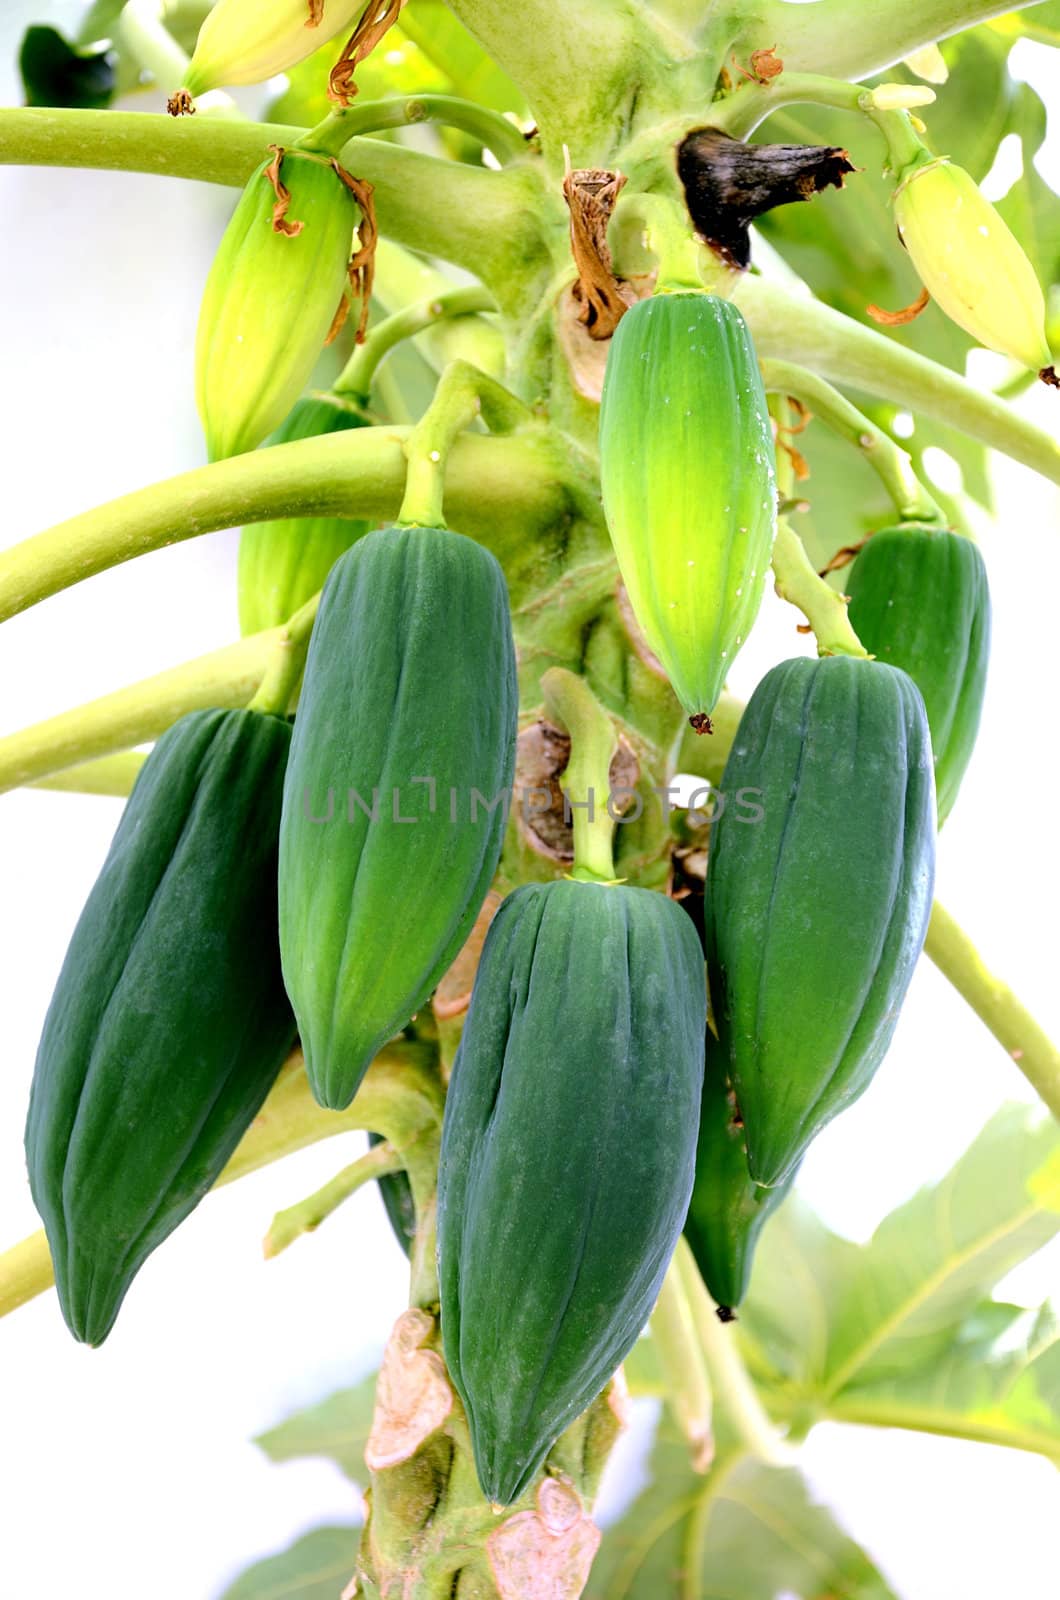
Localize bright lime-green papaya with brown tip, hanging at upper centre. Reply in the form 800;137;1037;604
600;294;777;731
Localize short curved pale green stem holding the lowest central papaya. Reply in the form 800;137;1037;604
541;667;618;883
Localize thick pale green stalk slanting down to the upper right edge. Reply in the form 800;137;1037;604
733;278;1060;483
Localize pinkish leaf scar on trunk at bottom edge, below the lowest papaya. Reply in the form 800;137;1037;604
485;1477;600;1600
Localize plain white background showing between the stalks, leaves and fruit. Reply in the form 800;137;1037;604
0;0;1060;1600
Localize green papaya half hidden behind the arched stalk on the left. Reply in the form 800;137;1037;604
239;394;368;634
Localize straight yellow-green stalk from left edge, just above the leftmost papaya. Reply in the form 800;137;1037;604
0;627;283;794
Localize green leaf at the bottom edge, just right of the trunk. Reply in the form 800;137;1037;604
586;1419;893;1600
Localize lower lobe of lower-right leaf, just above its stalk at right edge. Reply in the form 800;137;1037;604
829;1301;1060;1464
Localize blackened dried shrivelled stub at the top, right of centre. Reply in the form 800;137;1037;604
677;128;855;267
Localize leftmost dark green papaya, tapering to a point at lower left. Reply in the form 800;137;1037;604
26;710;295;1344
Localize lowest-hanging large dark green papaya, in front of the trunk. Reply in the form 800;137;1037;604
439;880;706;1506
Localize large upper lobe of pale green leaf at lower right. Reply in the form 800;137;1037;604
743;1106;1060;1430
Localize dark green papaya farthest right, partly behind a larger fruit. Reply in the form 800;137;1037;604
847;526;990;822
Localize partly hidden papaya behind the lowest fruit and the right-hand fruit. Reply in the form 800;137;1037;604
685;1034;796;1322
